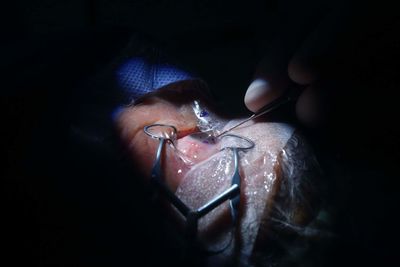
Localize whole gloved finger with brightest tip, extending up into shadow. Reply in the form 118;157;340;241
244;0;332;112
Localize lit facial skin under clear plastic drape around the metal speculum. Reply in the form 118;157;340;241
117;82;316;265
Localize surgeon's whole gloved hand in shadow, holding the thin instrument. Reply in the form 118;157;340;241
244;0;393;129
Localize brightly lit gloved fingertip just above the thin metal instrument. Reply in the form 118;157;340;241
244;79;279;112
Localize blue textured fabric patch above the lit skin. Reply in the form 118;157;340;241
116;57;192;101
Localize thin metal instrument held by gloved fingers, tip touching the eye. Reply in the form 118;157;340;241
215;88;301;137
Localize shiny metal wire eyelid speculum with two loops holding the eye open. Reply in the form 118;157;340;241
143;124;255;253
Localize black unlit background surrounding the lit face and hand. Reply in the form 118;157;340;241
0;0;400;266
